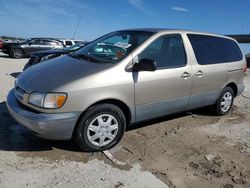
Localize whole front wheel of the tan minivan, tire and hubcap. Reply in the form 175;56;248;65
75;104;126;152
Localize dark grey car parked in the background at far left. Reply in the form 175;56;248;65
2;38;65;59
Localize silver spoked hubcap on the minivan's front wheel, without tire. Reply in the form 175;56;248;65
87;114;118;147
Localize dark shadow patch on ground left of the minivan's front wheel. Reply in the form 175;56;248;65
0;102;81;152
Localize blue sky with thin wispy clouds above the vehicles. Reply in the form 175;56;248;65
0;0;250;52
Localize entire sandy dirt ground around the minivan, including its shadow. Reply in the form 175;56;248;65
0;51;250;188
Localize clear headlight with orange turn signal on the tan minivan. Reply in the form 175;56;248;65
28;92;67;109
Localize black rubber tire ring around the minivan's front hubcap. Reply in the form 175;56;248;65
77;104;126;151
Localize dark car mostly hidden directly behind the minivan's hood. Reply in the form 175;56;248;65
23;43;87;70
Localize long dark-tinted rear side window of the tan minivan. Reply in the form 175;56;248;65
188;34;243;65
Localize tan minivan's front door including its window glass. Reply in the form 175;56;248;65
133;34;192;121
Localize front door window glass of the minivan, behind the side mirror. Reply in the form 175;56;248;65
139;34;186;69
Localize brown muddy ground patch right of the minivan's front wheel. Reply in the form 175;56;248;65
110;94;250;187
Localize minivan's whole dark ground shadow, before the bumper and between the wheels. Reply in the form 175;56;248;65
0;98;215;152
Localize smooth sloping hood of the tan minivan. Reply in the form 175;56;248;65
16;55;111;93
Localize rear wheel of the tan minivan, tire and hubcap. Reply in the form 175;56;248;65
213;87;234;116
